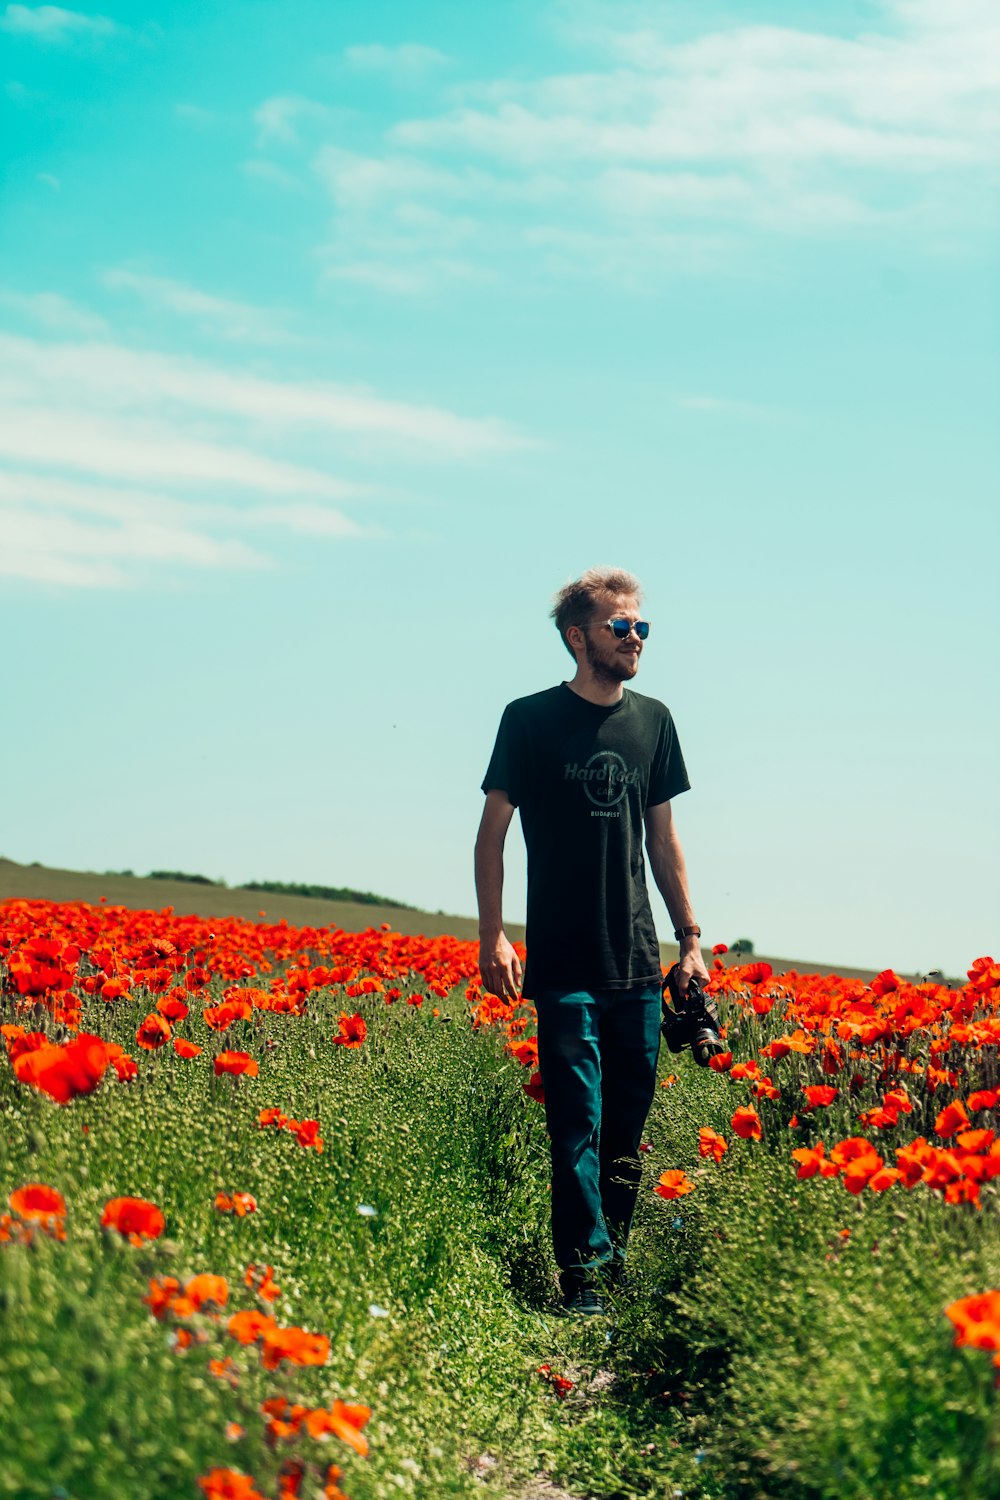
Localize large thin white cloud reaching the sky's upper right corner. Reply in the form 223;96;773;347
293;0;1000;294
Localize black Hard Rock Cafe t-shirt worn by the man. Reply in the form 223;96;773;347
483;683;690;996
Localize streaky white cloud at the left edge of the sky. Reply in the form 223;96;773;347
0;322;523;588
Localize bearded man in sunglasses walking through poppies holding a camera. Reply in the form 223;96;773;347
475;569;708;1316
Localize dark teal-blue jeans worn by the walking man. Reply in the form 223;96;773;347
535;984;660;1293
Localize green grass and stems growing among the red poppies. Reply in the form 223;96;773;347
0;960;1000;1500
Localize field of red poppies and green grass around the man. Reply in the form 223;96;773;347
0;900;1000;1500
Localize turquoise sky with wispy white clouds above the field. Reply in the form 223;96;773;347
0;0;1000;974
